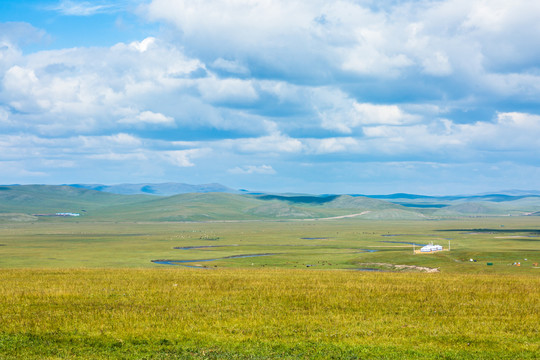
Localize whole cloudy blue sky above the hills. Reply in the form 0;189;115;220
0;0;540;195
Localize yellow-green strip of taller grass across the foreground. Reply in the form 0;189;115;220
0;268;540;359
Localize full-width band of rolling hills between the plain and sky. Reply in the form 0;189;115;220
0;184;540;221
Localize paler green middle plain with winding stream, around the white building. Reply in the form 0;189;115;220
0;217;540;275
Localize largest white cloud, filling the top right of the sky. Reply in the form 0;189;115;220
142;0;540;95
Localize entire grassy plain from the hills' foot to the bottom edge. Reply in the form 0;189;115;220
0;193;540;359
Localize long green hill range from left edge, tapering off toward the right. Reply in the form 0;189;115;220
0;185;402;221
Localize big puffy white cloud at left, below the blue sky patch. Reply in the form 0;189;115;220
0;38;205;135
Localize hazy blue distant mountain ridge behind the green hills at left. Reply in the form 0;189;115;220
69;182;240;196
